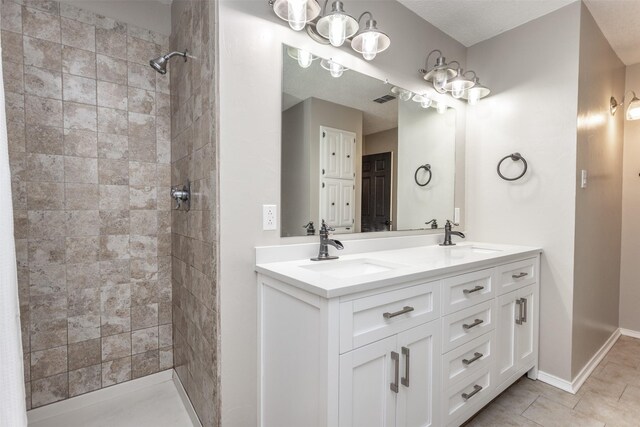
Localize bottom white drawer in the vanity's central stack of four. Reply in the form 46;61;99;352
442;366;493;425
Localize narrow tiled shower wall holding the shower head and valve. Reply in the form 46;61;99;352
171;0;220;427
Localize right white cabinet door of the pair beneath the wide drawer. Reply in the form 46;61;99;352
396;320;441;427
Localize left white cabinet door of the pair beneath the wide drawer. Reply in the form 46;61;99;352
338;336;400;427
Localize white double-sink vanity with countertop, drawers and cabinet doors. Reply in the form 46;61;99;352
256;236;541;427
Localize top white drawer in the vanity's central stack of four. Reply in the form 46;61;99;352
442;268;494;314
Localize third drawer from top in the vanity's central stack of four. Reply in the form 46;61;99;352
442;331;495;389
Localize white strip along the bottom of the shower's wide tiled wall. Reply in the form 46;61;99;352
27;369;173;424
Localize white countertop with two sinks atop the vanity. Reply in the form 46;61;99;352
256;242;542;298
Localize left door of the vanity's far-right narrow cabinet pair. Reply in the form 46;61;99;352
496;291;518;385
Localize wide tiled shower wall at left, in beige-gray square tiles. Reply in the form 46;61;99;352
0;0;173;408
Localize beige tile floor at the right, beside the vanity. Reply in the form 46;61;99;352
465;336;640;427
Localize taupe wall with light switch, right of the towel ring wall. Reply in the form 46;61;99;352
571;4;624;378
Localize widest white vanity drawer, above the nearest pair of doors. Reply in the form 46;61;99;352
340;282;440;354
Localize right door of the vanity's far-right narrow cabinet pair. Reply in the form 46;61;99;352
515;285;538;369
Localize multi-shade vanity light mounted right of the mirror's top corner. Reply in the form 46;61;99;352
419;49;491;105
